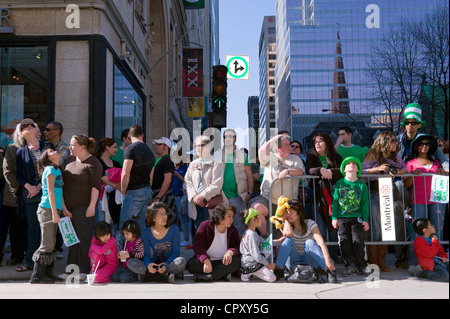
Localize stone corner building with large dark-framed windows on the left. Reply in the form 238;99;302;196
0;0;217;146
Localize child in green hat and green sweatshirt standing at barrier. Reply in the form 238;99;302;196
331;157;369;276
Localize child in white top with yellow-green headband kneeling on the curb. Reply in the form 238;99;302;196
239;208;277;282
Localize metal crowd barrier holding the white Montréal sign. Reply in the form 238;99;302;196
268;174;449;246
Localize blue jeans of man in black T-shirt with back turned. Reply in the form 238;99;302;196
119;186;153;239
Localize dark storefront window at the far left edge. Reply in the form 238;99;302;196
0;46;48;147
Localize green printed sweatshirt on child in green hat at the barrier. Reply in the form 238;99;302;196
331;177;369;222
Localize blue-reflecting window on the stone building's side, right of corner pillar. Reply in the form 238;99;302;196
114;65;145;145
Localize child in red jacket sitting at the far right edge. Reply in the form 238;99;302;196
413;218;449;282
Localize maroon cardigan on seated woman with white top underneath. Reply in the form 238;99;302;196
193;220;240;263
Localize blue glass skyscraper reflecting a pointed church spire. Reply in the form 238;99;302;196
275;0;448;144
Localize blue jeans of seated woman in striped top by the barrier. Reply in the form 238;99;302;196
276;237;325;270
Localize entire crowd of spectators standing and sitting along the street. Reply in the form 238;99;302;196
0;104;449;283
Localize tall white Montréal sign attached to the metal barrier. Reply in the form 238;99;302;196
378;177;395;241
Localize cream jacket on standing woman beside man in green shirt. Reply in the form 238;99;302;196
184;158;227;220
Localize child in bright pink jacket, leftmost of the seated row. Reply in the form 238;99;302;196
89;222;119;283
